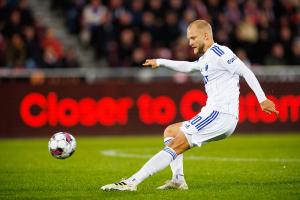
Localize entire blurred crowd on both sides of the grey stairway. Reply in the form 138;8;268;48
0;0;300;67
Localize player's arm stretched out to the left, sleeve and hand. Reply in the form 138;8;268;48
143;59;199;72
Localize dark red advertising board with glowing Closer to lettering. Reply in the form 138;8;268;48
0;82;300;137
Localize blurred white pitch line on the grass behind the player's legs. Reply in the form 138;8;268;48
100;149;300;163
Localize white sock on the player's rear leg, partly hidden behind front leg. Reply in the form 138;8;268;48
164;137;185;182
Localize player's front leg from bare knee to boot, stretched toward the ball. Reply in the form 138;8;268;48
101;132;190;191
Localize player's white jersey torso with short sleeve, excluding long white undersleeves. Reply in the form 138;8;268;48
196;43;244;117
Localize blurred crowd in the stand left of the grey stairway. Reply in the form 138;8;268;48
0;0;79;68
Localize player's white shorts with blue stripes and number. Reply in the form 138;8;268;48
180;107;238;147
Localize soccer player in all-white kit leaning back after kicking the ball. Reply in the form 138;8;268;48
101;20;278;191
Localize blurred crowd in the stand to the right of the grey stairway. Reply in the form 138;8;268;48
52;0;300;66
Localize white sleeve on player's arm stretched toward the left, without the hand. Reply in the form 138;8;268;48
156;59;200;72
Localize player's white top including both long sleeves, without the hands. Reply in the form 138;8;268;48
157;43;266;117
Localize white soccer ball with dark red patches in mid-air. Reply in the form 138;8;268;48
48;132;76;159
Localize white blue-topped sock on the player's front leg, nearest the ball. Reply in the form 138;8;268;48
127;147;177;184
